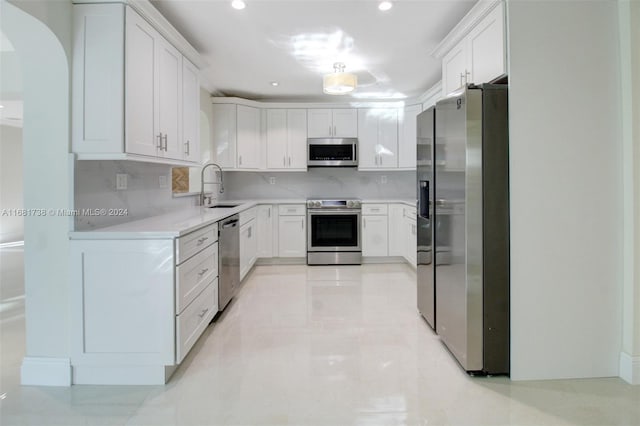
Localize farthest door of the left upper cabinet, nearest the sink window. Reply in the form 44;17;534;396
182;57;200;163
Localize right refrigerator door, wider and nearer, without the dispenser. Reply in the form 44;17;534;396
434;87;483;371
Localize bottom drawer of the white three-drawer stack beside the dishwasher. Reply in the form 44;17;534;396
176;278;218;364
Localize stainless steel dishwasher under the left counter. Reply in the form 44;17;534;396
218;214;240;311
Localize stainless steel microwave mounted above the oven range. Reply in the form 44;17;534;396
307;138;358;167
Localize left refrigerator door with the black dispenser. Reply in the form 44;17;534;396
416;107;436;329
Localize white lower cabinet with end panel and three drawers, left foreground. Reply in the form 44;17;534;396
70;224;218;385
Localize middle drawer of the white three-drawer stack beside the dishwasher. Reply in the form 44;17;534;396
176;243;218;313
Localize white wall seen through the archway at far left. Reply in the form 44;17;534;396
0;126;24;243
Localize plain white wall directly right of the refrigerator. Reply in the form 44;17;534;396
508;0;623;380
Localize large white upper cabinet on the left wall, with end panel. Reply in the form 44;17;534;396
72;3;200;165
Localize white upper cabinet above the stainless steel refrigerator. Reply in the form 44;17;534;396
433;0;507;95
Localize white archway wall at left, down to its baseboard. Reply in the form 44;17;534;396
0;0;72;385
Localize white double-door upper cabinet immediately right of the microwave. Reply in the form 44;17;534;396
358;108;398;170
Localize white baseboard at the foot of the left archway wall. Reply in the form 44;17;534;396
20;357;71;386
